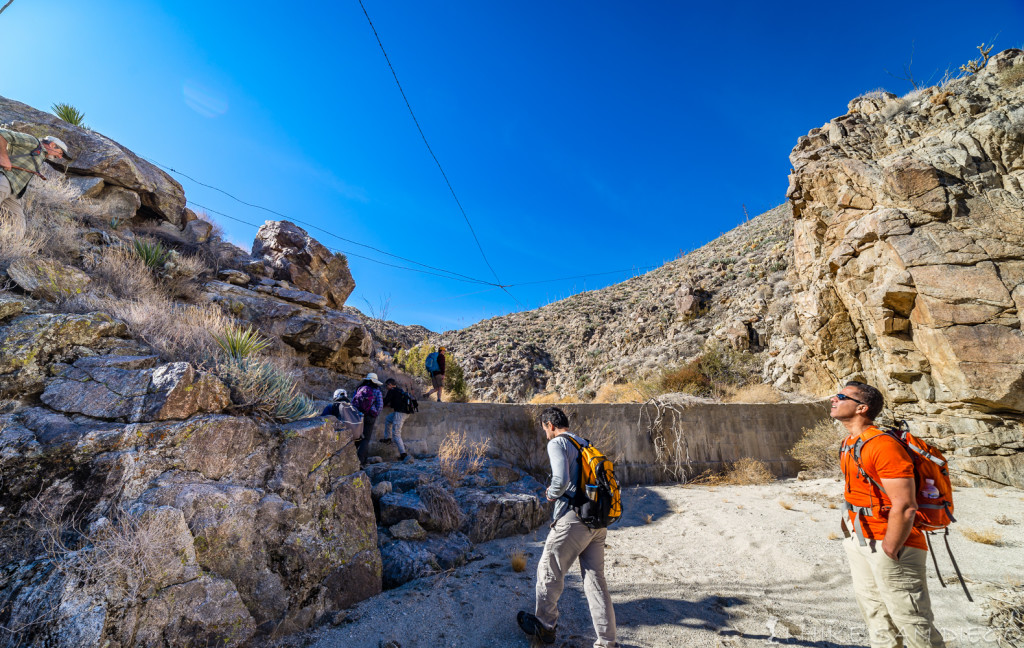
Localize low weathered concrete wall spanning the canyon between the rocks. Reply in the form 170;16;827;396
402;401;827;484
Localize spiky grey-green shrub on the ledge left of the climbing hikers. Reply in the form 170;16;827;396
214;355;316;422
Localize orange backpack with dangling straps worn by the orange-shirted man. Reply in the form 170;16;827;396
840;421;974;601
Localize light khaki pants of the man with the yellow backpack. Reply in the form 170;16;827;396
537;511;618;648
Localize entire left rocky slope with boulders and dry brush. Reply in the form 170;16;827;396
0;97;549;648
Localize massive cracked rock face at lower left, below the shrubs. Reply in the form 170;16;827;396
0;309;381;647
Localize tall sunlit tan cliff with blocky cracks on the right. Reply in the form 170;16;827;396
772;50;1024;487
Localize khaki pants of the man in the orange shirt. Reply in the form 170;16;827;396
843;536;945;648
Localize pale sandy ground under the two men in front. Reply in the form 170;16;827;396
286;479;1024;648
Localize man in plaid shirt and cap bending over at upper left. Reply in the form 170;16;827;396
0;128;72;223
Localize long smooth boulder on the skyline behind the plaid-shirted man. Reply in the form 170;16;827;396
0;96;185;227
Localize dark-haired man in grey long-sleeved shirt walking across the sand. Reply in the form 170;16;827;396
516;407;618;648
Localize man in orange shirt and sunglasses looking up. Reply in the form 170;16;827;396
830;382;945;648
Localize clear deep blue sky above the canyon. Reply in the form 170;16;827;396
0;0;1024;331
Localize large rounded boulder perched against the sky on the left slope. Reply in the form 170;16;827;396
253;220;355;309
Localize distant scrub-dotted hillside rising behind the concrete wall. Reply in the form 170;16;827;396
442;205;796;400
